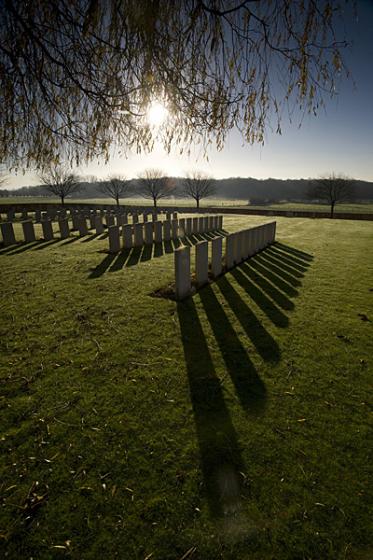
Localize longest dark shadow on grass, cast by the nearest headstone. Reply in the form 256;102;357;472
177;298;245;518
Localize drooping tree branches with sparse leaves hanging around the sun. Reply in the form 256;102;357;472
0;0;353;167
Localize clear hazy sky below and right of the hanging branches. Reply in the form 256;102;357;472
5;0;373;187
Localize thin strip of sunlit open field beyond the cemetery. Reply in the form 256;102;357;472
0;196;373;213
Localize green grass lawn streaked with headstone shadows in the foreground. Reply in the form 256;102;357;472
0;216;373;560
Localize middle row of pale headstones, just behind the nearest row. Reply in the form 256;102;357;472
108;214;223;253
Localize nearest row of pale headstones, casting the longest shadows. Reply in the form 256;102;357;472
175;222;276;300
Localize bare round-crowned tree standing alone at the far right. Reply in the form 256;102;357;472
307;173;354;218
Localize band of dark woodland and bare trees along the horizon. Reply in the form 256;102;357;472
0;169;373;207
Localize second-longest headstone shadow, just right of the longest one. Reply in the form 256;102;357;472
199;286;269;414
